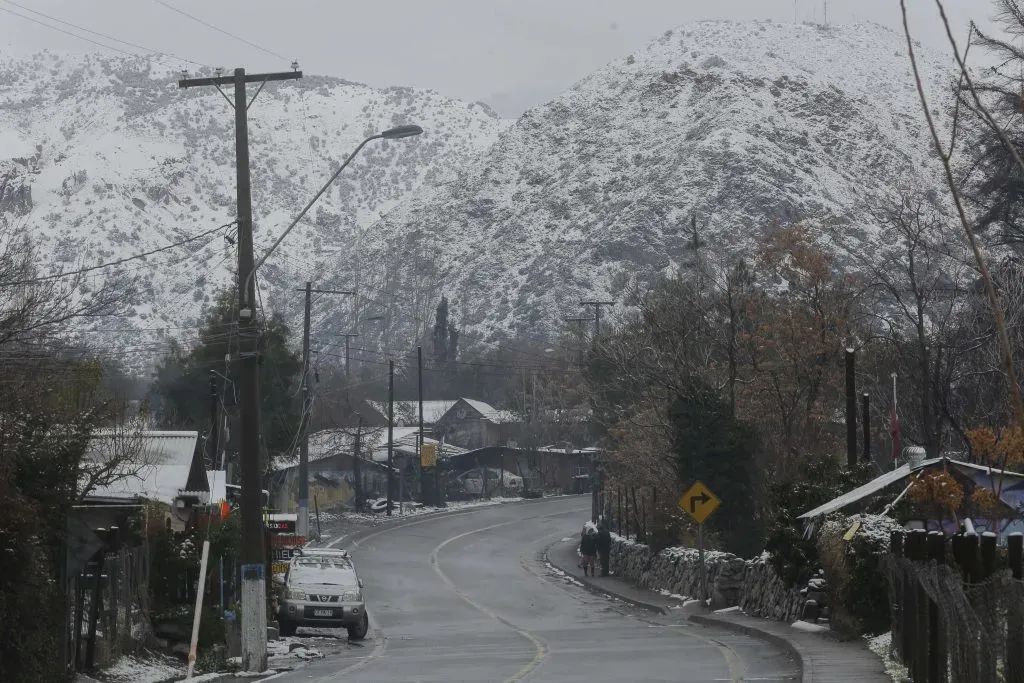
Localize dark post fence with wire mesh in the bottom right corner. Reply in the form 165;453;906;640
886;530;1024;683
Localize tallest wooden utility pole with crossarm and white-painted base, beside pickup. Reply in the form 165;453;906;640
178;63;302;673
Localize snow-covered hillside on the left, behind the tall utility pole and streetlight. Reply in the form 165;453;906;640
0;52;508;354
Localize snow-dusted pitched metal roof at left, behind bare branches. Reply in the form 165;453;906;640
83;430;199;504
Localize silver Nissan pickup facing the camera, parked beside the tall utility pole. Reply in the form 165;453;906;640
278;548;370;640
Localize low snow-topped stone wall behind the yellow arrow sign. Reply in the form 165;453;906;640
611;535;804;622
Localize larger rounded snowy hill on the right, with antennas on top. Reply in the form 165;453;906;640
325;23;948;348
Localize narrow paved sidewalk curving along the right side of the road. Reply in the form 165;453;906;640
545;543;892;683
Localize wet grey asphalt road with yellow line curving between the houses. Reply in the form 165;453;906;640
275;497;797;683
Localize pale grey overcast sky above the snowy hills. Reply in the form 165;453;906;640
0;0;1007;116
